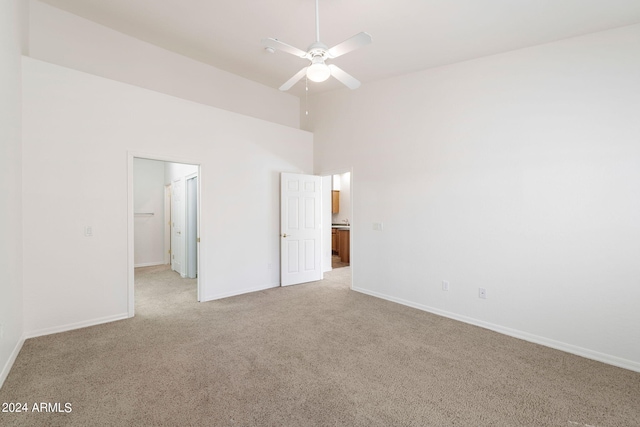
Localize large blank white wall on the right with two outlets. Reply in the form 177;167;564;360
310;25;640;371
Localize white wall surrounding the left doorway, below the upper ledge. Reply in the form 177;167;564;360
23;58;313;336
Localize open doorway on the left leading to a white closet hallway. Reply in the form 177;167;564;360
128;153;202;317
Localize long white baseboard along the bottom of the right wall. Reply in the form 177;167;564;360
353;287;640;372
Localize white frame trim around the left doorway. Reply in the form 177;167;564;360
127;151;206;317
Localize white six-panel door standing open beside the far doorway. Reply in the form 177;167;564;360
280;173;322;286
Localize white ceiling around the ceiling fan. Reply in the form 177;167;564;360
42;0;640;95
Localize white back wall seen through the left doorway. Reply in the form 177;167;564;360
133;159;165;267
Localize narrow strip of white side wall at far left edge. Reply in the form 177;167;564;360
0;0;23;387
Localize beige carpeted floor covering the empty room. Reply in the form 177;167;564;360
0;267;640;427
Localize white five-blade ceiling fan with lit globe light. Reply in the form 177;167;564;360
262;0;371;91
